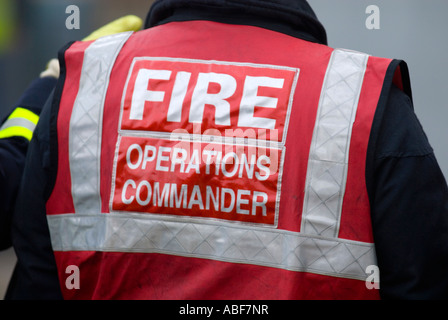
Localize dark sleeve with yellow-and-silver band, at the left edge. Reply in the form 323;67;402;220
0;77;56;250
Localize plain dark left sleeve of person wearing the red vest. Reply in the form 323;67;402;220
5;88;62;300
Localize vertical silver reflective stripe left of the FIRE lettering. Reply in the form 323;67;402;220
69;32;132;213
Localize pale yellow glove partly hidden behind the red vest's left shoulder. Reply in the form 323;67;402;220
40;15;143;78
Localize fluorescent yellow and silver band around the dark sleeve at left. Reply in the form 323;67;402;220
0;108;39;141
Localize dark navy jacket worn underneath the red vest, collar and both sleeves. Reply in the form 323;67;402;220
7;0;448;299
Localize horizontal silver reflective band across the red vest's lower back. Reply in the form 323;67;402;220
48;213;376;280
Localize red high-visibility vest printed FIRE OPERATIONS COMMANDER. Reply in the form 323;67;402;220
47;21;408;299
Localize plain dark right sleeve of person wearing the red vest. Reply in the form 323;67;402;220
368;87;448;299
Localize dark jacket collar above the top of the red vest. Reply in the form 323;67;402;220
145;0;327;44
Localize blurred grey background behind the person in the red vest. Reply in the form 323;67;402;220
0;0;448;298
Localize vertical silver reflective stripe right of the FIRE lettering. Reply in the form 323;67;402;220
301;49;368;238
